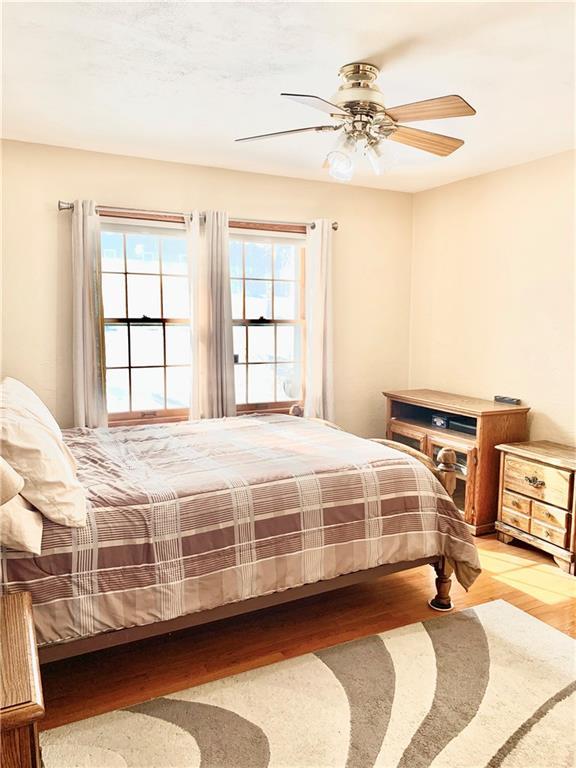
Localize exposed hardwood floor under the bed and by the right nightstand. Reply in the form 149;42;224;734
40;537;576;729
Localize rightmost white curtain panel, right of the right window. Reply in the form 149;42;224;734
304;219;334;421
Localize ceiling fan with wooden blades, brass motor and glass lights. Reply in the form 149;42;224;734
236;62;476;181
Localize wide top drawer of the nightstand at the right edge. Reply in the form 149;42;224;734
504;455;572;509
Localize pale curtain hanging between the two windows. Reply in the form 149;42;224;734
188;211;236;419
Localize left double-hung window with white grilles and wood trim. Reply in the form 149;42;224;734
101;224;191;423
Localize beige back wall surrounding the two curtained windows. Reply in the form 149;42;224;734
2;141;412;436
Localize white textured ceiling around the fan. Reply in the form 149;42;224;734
3;2;574;191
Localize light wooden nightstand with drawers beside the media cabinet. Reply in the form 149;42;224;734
496;440;576;575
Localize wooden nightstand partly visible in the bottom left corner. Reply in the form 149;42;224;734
0;592;44;768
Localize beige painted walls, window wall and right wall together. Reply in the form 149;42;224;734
2;142;576;442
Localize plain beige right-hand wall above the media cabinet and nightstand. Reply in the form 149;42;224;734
409;152;576;443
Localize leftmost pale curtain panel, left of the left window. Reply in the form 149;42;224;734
72;200;108;427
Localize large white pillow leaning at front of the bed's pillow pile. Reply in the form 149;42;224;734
0;408;86;528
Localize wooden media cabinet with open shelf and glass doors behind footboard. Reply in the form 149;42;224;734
383;389;530;536
